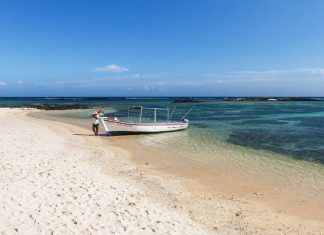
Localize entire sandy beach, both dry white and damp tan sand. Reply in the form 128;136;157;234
0;109;324;234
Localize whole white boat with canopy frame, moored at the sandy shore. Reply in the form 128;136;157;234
100;106;189;134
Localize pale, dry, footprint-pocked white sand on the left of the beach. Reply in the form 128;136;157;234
0;109;207;234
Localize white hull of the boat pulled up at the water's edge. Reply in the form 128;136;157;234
103;120;188;133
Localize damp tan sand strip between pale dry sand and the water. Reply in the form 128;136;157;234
101;136;324;234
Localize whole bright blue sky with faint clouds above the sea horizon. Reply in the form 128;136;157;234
0;0;324;96
